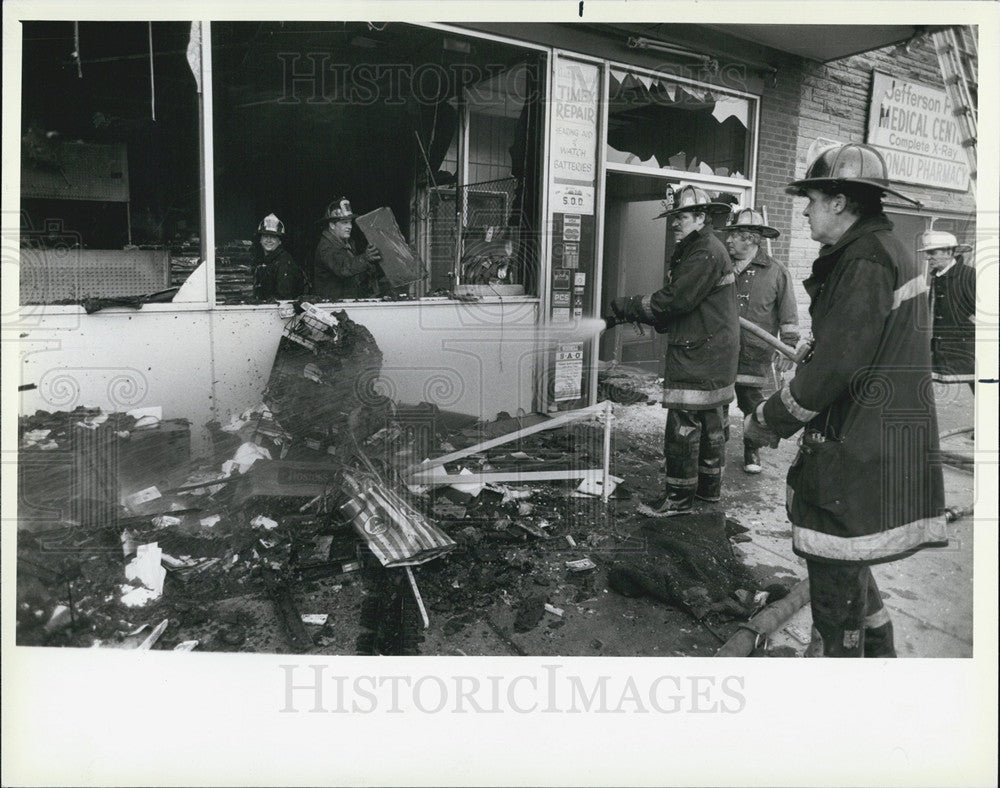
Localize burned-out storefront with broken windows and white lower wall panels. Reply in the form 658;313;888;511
11;16;973;450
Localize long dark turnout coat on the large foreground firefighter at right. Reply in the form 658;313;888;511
763;214;947;564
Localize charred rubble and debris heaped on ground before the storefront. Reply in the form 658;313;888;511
17;309;780;654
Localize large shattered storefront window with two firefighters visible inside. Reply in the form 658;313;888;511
206;22;544;303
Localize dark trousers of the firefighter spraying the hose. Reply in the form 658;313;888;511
663;406;726;501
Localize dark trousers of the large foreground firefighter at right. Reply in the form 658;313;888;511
806;561;896;657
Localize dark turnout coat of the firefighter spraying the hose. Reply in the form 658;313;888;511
626;226;740;410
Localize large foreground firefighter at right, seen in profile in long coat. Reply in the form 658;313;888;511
743;143;947;657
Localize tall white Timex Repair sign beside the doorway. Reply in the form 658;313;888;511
549;58;600;216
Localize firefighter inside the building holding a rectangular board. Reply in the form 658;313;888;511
313;197;382;301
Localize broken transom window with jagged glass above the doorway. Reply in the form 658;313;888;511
606;68;755;180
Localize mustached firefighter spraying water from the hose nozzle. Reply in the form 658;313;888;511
611;186;739;517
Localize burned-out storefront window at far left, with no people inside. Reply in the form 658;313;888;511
20;21;201;304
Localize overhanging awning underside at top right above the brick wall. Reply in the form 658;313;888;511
705;25;945;63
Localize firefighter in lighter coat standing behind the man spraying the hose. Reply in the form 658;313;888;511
726;208;799;473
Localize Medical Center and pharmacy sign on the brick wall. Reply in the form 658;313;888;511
866;71;969;191
